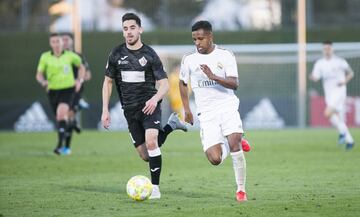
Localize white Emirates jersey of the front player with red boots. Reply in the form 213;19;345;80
179;46;239;113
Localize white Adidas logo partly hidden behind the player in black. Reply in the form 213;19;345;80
97;102;128;131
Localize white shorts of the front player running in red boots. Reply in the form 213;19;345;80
198;108;244;152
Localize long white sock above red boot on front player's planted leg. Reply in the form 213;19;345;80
230;150;246;192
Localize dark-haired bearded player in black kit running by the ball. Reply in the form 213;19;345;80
101;13;187;199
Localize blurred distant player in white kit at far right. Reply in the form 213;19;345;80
310;41;354;149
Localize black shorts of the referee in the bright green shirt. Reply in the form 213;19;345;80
48;87;75;114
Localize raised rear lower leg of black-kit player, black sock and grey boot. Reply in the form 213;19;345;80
158;112;187;147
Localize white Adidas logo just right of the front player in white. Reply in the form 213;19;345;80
244;98;285;129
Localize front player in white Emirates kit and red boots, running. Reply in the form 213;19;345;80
179;21;247;202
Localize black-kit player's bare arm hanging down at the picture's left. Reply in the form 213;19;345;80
101;76;112;129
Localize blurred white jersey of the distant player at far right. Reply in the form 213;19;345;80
312;55;350;98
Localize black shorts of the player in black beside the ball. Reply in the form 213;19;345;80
124;103;162;147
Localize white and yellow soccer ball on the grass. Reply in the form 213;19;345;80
126;175;153;201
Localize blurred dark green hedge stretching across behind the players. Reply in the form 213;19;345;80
0;28;360;102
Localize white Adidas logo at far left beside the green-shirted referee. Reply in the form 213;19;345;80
14;102;55;132
